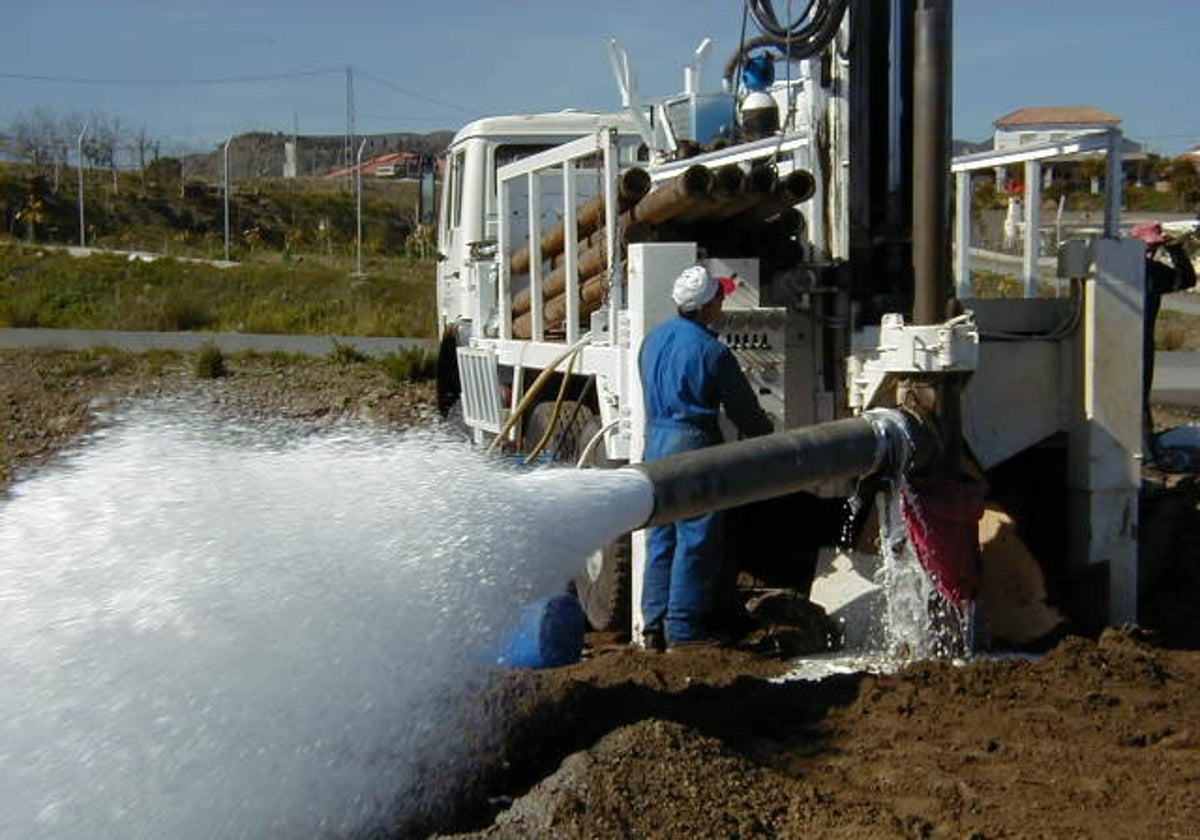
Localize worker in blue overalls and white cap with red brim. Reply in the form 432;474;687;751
638;265;772;650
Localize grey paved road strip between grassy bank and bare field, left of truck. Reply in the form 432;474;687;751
0;329;436;356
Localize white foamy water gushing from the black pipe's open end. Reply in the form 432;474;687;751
0;407;650;840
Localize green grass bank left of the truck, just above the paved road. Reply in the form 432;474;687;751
0;240;436;338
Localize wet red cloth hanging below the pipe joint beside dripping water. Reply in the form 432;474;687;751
900;479;985;606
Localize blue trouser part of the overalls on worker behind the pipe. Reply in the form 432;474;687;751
642;421;721;644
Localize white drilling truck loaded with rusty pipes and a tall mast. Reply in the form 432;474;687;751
437;0;1140;643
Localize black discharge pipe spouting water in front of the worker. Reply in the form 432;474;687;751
626;408;932;528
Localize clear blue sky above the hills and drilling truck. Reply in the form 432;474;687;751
0;0;1200;154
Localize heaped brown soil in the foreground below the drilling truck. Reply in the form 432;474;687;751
429;631;1200;839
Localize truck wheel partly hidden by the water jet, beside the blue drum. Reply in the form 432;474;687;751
524;400;632;631
